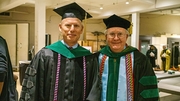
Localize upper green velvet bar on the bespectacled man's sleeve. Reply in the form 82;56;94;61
139;76;157;86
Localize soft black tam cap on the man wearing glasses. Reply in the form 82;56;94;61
103;14;131;30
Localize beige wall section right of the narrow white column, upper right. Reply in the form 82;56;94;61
140;14;180;35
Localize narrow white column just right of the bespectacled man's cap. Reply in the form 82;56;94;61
131;13;140;49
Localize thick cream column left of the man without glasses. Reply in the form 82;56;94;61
35;0;46;53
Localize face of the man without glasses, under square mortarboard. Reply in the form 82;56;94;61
59;18;83;46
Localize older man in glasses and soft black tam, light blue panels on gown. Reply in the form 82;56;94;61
97;15;159;101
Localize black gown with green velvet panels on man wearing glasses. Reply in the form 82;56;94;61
96;46;159;101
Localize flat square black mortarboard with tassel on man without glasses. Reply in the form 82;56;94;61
54;2;92;21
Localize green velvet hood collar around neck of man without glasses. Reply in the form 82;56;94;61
46;41;91;58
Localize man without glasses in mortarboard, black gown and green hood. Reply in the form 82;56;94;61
20;3;100;101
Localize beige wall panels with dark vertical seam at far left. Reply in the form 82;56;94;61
0;23;29;67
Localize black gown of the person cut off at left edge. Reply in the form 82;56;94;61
0;36;18;101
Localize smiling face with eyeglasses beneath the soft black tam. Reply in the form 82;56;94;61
106;27;128;53
